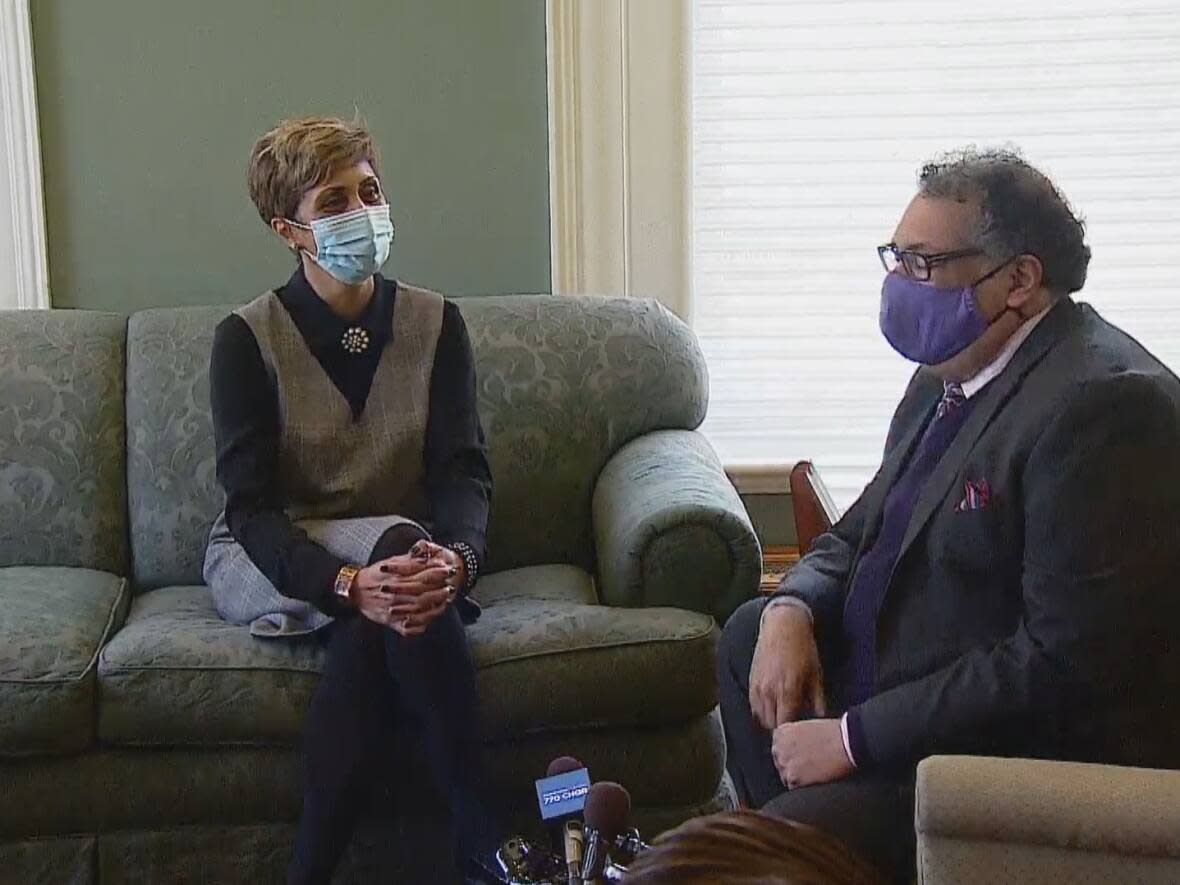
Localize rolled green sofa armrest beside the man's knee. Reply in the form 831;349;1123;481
594;431;762;623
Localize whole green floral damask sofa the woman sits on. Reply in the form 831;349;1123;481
0;296;760;884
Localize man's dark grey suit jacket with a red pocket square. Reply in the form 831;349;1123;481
780;299;1180;767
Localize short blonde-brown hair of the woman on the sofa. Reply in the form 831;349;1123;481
247;117;380;224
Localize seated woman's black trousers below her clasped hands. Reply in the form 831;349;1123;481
287;526;503;885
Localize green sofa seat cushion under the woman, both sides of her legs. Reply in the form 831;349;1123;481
98;565;716;746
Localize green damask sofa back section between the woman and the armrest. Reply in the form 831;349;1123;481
458;295;708;571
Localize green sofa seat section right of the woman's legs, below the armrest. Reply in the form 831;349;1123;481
467;565;717;740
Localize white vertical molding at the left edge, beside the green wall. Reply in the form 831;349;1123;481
0;0;50;308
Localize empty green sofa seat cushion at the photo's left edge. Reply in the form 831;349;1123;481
0;566;129;756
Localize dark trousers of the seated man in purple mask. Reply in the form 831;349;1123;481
717;599;915;883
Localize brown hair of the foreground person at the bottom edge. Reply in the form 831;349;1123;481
623;811;884;885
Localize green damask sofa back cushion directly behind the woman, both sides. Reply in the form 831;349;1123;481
127;295;708;589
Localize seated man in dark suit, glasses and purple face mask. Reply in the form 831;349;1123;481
719;151;1180;879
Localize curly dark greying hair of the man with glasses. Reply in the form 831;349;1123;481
918;148;1090;295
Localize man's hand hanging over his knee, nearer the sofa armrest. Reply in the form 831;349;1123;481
749;605;827;732
